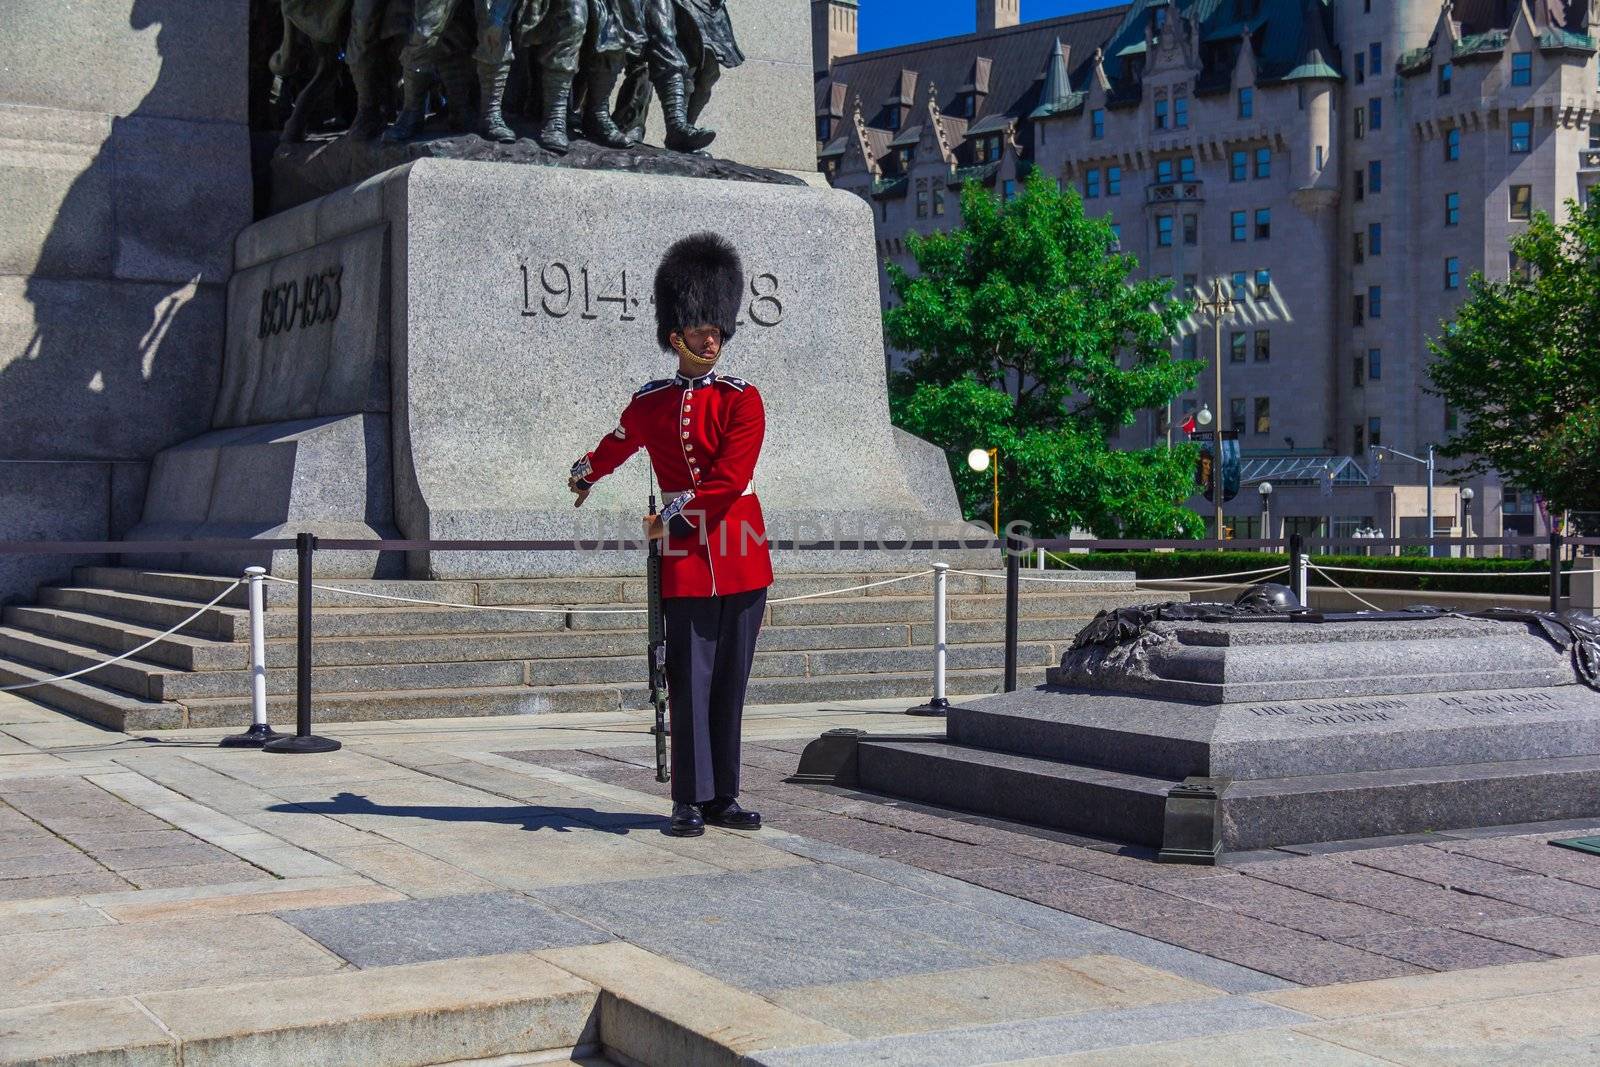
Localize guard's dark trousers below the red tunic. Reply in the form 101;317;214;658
661;589;766;805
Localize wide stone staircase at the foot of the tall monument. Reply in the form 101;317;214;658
0;566;1150;731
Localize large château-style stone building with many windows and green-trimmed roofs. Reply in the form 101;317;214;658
813;0;1600;547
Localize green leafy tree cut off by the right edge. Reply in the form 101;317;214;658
1429;197;1600;510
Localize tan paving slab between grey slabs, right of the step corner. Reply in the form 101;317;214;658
770;955;1219;1037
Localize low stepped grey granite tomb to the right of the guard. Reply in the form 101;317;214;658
802;617;1600;862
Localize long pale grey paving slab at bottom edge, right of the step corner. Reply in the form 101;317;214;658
749;997;1306;1067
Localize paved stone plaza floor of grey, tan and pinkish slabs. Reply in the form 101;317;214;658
0;696;1600;1067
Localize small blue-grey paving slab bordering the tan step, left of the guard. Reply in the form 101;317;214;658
278;893;611;968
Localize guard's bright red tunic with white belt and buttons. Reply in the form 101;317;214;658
573;371;773;597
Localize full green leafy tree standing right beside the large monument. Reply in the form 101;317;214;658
883;171;1203;537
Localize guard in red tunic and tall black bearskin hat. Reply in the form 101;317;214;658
568;234;773;837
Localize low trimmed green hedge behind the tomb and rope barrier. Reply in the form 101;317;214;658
1050;552;1571;595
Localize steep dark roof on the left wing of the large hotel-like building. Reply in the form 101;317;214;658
818;6;1128;150
